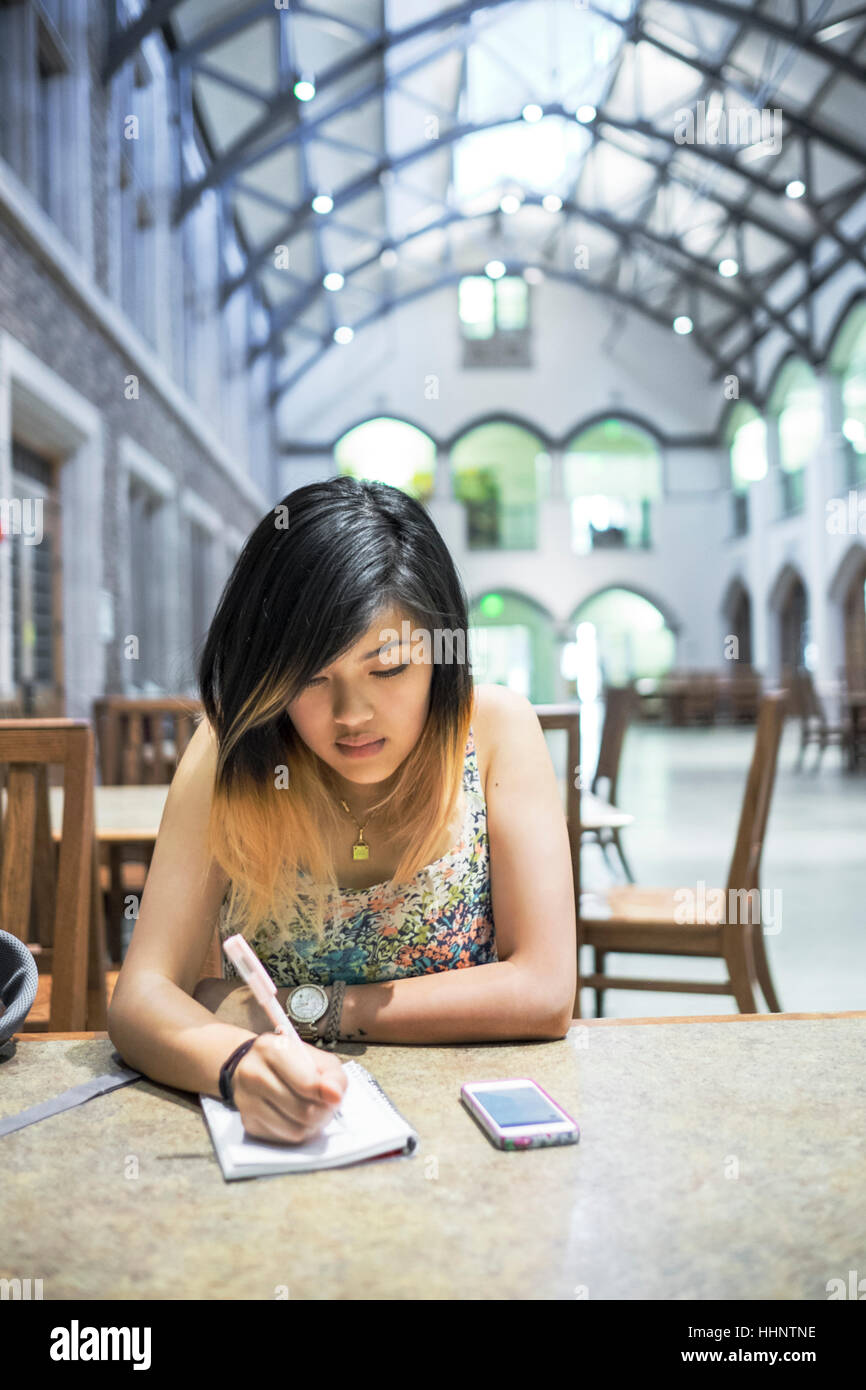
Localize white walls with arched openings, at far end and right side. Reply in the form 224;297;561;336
277;255;866;692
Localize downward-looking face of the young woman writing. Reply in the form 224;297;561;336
288;609;432;787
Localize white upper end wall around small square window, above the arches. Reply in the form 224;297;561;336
277;281;724;442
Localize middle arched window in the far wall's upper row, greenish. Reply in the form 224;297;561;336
450;420;550;550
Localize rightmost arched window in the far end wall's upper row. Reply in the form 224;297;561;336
563;420;662;555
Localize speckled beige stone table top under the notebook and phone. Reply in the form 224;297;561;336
0;1015;866;1300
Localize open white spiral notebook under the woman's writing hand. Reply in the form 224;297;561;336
199;1061;418;1182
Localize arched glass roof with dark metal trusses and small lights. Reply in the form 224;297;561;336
104;0;866;399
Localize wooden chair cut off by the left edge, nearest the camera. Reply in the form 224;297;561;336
0;719;107;1033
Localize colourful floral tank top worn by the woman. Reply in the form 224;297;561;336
218;728;496;987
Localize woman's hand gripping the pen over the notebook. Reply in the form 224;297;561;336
232;1031;349;1144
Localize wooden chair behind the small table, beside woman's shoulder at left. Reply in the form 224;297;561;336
93;695;202;965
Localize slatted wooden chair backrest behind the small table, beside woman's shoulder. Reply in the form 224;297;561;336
93;695;202;787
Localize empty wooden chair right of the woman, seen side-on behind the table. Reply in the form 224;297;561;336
575;691;788;1017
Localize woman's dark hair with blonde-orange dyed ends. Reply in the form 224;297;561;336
197;477;473;937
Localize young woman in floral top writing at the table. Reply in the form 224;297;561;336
108;477;575;1143
